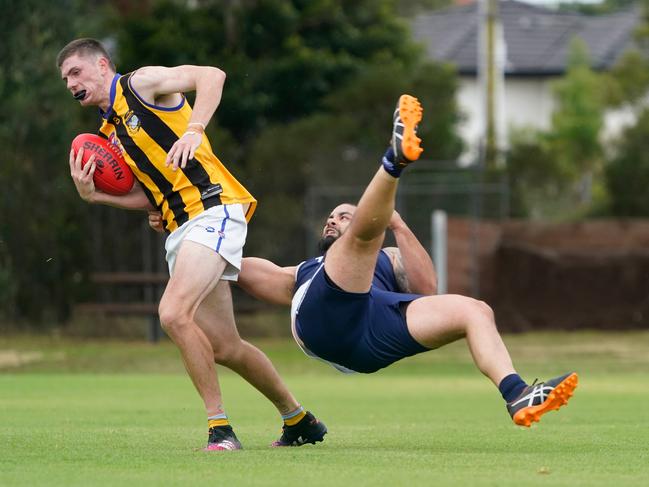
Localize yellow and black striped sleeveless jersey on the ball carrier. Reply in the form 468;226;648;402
99;73;257;232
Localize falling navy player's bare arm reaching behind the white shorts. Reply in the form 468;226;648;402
237;257;295;306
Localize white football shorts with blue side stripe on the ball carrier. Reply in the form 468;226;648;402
165;204;248;281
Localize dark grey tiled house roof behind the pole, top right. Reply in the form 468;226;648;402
413;0;640;76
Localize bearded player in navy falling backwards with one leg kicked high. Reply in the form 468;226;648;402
235;95;578;426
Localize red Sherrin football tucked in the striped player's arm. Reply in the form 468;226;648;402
72;134;134;196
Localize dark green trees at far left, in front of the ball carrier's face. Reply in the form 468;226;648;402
0;0;115;321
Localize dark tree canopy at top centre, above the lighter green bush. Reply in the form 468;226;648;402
118;0;419;143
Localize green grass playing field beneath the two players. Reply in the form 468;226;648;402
0;333;649;487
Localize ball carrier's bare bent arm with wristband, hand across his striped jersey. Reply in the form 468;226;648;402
131;65;225;170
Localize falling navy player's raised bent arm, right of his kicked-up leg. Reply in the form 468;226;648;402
384;211;437;295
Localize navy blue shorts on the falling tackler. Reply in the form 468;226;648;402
296;269;429;373
